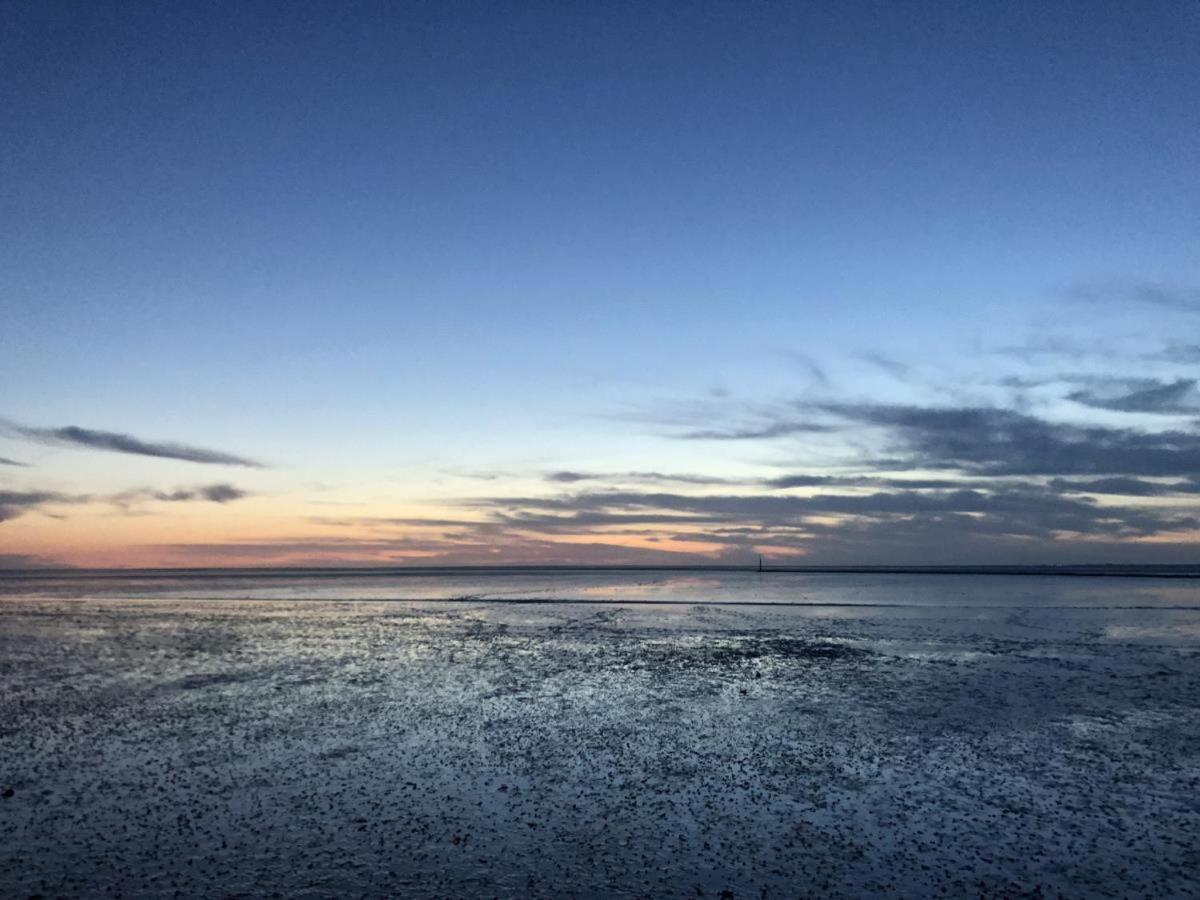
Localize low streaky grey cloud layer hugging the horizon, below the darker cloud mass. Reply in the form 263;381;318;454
260;465;1200;565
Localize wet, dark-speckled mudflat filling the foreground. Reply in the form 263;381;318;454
0;598;1200;898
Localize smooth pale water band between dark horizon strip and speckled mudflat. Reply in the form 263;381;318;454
0;569;1200;610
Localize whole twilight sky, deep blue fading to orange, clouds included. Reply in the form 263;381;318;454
0;0;1200;568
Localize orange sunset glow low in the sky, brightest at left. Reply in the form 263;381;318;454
7;480;1200;568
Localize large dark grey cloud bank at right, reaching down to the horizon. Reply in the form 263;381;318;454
290;379;1200;564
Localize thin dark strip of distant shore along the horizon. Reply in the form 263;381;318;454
0;564;1200;580
